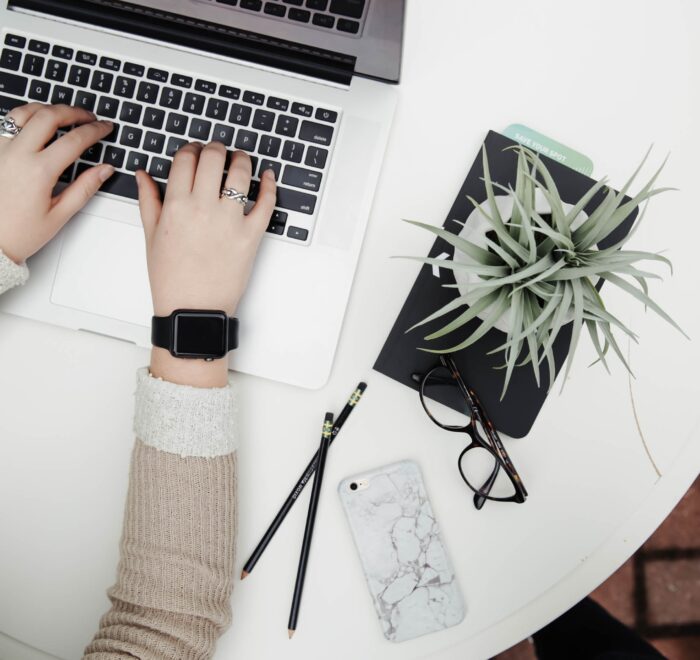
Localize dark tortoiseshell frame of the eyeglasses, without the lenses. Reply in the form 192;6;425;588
413;355;527;509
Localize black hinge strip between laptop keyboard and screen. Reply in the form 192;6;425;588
7;0;355;85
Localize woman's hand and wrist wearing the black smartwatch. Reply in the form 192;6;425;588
136;142;276;387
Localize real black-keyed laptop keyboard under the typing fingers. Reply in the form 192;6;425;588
0;33;340;245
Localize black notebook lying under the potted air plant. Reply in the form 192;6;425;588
374;131;637;438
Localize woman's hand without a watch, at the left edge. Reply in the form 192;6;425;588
0;103;114;264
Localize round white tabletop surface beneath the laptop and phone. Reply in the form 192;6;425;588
0;0;700;660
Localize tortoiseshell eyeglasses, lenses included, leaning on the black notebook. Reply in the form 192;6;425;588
412;355;527;509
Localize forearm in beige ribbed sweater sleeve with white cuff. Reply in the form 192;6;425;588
85;368;236;660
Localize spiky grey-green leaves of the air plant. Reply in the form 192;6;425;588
407;147;687;398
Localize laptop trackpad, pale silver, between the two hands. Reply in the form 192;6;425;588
51;213;153;326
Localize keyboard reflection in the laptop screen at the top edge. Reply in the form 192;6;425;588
200;0;369;37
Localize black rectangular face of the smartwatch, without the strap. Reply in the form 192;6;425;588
173;312;228;359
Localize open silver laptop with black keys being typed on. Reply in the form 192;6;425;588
0;0;404;388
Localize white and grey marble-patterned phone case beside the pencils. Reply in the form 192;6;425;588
338;461;464;642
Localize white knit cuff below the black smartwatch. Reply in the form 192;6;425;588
134;368;238;458
